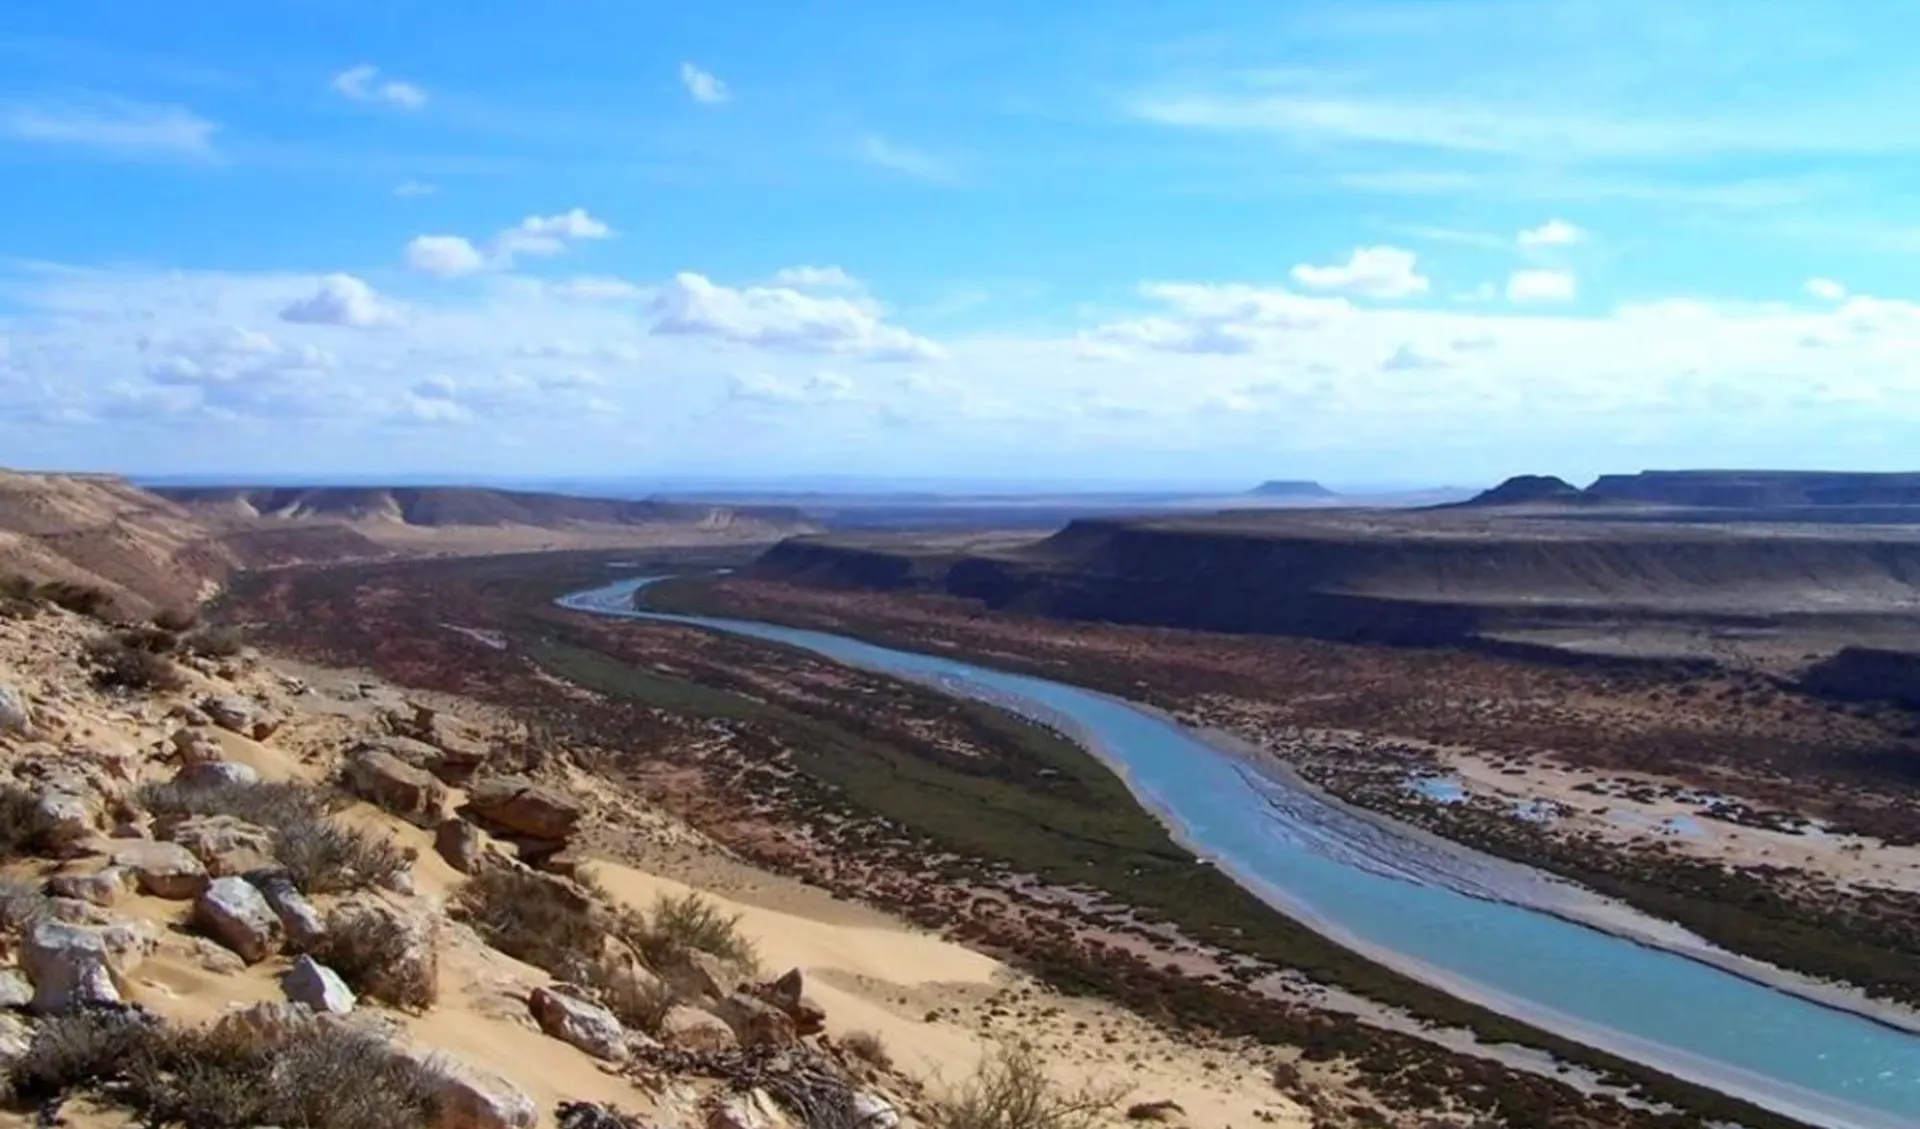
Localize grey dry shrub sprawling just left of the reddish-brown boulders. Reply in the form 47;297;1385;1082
140;783;413;895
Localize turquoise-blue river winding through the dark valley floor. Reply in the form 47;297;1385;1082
561;580;1920;1129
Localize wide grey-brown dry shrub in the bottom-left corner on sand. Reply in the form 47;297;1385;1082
10;1010;436;1129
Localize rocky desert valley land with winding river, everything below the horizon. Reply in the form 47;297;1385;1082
0;464;1920;1129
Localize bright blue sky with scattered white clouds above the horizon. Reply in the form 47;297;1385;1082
0;0;1920;484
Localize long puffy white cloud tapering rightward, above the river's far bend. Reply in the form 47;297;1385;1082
653;273;945;361
